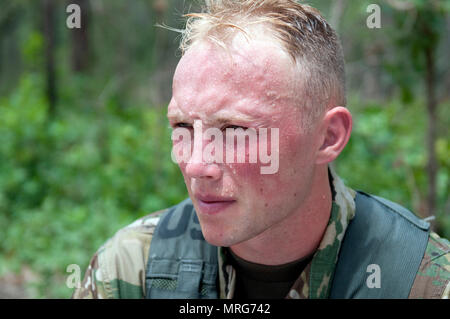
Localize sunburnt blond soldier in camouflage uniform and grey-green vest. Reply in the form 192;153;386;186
73;0;450;299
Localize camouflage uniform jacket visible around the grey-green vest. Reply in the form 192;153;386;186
72;172;450;299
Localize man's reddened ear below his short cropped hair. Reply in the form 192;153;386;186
316;106;352;164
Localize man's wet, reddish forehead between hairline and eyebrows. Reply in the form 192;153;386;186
169;37;294;122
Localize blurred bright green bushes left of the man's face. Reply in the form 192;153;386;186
0;75;187;297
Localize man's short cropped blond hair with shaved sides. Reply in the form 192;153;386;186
180;0;346;124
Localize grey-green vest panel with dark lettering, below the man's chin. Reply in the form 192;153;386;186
145;199;217;299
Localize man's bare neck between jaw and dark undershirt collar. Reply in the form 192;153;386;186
230;169;332;265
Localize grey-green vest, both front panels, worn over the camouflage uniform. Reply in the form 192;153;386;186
146;192;429;299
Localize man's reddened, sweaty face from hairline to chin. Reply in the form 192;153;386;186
168;40;318;247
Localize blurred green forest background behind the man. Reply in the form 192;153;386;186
0;0;450;298
